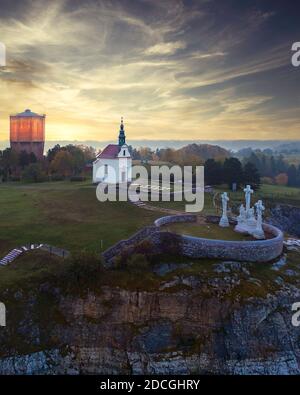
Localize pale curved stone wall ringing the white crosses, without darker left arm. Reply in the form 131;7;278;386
155;214;283;262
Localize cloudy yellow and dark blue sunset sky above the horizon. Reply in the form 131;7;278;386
0;0;300;140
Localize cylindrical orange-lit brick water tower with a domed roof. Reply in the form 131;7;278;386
10;110;46;159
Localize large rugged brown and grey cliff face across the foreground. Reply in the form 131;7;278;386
0;262;300;374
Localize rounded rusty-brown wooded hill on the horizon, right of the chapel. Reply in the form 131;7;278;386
177;144;231;160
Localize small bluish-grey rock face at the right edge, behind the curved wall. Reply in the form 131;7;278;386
268;204;300;237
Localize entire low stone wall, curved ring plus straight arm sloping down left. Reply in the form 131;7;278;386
102;214;283;266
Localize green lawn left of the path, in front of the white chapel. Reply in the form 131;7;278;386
0;181;160;256
